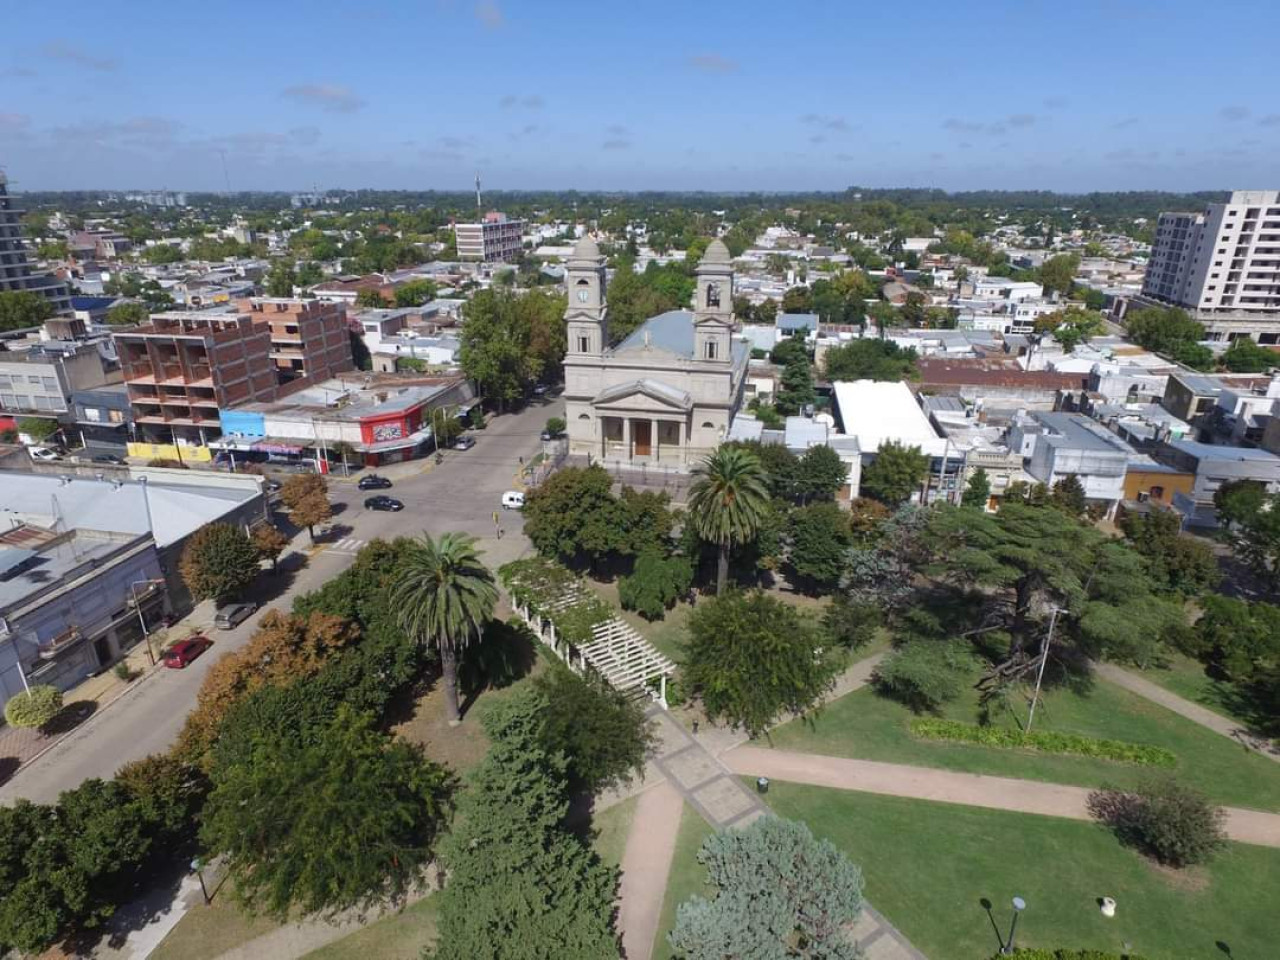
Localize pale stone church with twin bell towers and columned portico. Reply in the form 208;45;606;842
564;237;750;471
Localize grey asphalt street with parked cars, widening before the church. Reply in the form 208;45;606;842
0;401;563;803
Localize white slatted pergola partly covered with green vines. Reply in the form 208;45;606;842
515;582;676;708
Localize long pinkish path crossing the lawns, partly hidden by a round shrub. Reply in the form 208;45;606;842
723;746;1280;847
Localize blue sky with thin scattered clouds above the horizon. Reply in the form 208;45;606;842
0;0;1280;191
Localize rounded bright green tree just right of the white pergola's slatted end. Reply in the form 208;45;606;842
684;590;840;736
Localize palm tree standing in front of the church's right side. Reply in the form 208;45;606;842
689;447;769;594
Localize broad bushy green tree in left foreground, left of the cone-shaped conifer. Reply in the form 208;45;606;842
201;707;449;918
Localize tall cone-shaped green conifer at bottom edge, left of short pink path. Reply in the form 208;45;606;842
429;687;618;960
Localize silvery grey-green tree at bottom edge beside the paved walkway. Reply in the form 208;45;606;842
668;817;863;960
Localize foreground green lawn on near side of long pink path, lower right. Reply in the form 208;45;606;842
768;781;1280;960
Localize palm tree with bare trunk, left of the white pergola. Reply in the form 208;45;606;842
392;534;498;727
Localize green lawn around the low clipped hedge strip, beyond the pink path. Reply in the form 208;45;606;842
772;681;1280;810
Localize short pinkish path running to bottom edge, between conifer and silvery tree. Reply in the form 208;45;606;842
618;783;685;960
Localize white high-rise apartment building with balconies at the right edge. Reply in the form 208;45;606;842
1142;191;1280;344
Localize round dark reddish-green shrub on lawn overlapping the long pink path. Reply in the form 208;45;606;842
1089;777;1226;867
